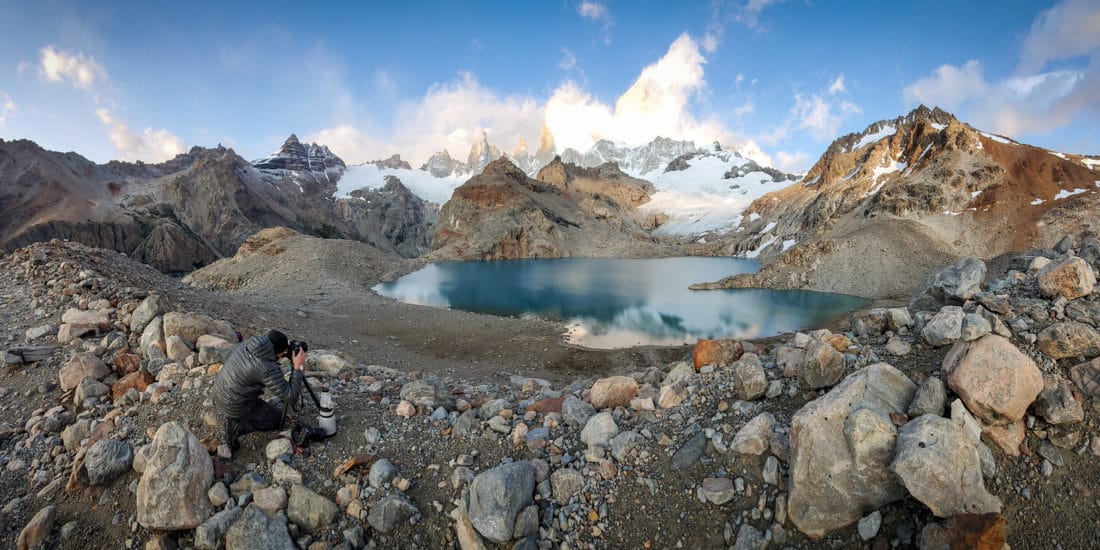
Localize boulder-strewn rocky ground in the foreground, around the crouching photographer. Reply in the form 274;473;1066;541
0;235;1100;548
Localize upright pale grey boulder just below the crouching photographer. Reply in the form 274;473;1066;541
138;422;213;531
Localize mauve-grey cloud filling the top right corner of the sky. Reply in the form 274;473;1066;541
1020;0;1100;74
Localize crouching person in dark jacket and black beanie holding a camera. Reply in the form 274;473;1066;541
213;330;306;451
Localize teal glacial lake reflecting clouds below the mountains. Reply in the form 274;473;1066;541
374;257;867;349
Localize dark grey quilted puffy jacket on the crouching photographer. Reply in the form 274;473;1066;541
213;336;303;418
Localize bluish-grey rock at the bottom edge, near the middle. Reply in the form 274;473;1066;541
470;461;535;543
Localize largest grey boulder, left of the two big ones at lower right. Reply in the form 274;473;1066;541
788;363;916;538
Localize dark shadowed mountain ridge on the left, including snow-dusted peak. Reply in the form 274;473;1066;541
0;135;436;272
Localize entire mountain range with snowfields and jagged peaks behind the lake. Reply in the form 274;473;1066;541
0;106;1100;297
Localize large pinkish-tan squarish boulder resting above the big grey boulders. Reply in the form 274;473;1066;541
943;334;1043;426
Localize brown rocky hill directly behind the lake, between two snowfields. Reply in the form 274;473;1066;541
428;158;669;260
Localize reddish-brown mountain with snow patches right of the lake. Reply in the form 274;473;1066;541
699;107;1100;298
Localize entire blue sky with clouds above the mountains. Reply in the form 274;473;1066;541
0;0;1100;171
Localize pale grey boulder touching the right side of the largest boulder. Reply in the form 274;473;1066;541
890;415;1001;517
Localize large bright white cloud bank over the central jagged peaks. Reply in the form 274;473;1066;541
306;34;756;165
